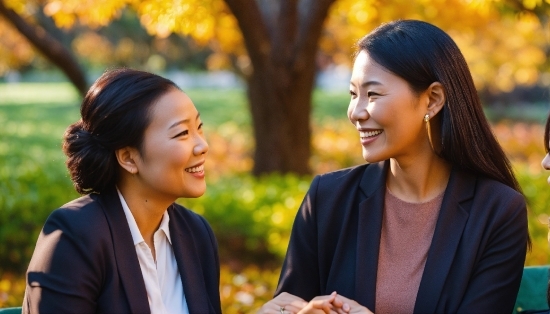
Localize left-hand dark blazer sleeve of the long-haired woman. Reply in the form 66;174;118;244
275;176;321;301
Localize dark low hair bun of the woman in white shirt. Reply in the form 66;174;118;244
63;120;116;194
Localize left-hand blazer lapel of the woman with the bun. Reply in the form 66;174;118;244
99;189;151;313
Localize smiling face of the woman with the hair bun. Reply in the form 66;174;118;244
136;89;208;199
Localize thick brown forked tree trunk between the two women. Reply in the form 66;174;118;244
225;0;335;175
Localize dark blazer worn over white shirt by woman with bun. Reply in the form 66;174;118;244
23;189;221;314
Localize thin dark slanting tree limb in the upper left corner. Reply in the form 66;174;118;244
0;0;88;96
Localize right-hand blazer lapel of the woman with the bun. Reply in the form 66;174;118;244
168;205;214;314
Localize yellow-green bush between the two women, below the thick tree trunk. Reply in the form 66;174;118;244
179;174;311;266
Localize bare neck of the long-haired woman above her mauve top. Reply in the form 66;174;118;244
386;153;451;203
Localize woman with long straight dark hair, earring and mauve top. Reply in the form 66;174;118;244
259;20;530;314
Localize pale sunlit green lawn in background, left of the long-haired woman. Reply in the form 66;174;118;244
0;83;349;139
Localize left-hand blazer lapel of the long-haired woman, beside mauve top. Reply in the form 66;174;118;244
355;161;389;312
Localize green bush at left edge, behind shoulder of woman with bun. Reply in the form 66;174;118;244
0;151;77;272
